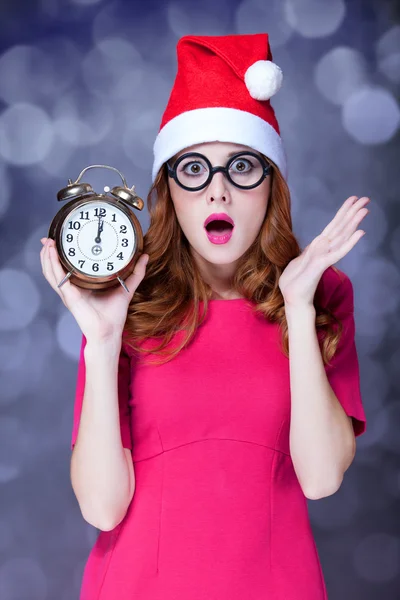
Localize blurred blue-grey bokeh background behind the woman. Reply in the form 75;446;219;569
0;0;400;600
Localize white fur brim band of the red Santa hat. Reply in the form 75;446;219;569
152;107;287;183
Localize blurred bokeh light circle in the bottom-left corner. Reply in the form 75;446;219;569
0;557;48;600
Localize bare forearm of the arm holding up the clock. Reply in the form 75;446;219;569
71;340;134;529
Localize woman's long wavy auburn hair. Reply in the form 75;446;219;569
123;155;343;365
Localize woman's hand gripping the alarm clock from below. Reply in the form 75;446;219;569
40;238;148;342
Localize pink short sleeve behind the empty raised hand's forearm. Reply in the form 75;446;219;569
325;272;366;436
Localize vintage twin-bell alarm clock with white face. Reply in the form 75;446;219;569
48;165;144;292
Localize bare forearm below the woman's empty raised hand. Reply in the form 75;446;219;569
286;306;355;499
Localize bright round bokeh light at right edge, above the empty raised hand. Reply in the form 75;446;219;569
342;87;400;145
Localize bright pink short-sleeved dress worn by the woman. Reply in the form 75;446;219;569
71;267;366;600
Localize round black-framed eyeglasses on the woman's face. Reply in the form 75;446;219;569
166;152;271;192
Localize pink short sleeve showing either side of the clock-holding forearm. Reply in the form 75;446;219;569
71;335;132;450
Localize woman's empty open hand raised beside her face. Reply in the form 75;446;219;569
279;196;370;306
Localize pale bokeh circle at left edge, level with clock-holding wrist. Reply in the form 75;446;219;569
0;268;40;331
